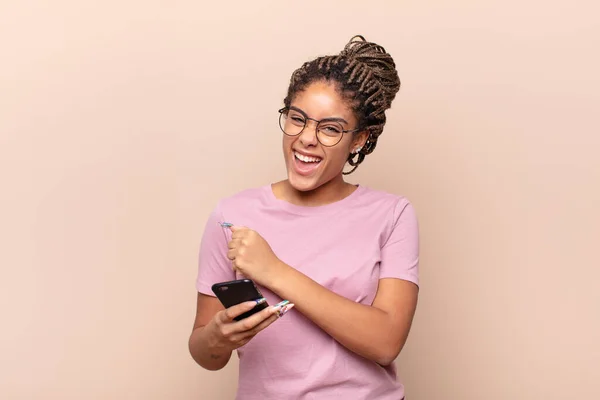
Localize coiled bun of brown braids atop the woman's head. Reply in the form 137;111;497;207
340;35;400;108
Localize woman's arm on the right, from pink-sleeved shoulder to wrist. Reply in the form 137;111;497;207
267;200;419;365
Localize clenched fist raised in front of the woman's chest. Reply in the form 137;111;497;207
227;226;282;287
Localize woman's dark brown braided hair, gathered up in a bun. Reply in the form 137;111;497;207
284;35;400;175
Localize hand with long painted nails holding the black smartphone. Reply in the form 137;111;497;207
207;301;294;353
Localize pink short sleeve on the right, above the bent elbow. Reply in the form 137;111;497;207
379;198;419;285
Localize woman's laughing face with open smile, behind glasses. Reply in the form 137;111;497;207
283;81;366;192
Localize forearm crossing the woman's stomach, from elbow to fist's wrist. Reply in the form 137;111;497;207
269;265;401;365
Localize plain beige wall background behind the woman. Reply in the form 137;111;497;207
0;0;600;400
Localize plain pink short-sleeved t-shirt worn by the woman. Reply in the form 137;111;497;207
196;185;419;400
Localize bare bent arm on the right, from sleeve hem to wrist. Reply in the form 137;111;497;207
271;266;418;366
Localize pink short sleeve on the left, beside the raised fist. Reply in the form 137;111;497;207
196;206;235;296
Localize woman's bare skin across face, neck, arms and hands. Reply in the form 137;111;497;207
189;82;418;370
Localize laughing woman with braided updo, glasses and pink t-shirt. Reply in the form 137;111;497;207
189;36;419;400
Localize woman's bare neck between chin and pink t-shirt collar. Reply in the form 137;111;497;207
273;174;356;207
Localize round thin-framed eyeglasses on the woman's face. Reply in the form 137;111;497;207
279;107;360;147
